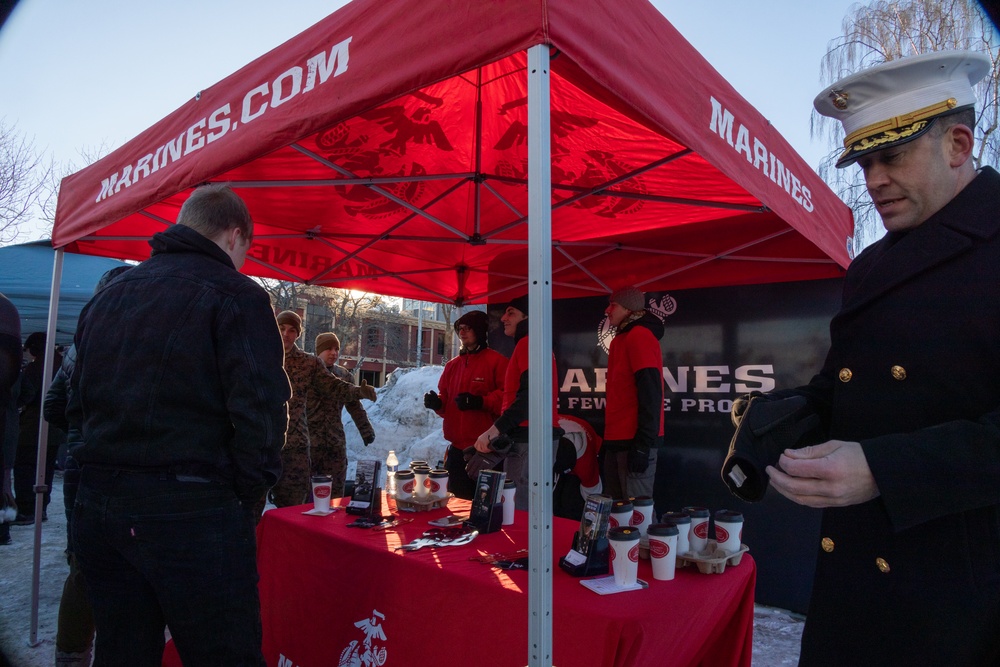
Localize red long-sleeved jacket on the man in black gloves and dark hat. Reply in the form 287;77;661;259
435;347;507;449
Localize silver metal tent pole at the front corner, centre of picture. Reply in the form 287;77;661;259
528;44;553;667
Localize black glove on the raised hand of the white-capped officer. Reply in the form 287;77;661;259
722;392;820;502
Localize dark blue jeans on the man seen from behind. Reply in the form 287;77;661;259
71;466;265;667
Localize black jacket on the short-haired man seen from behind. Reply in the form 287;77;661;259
67;225;291;503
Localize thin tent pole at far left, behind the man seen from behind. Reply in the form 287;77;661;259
28;248;65;646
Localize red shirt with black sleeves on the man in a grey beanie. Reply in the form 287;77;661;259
604;313;663;449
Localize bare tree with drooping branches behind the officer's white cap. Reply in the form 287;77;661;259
812;0;1000;254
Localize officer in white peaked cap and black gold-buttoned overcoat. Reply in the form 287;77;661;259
752;52;1000;666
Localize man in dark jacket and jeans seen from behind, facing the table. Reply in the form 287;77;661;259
67;185;291;667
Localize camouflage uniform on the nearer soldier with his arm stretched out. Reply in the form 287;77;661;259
271;346;361;507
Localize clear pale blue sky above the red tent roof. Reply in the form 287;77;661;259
0;0;853;240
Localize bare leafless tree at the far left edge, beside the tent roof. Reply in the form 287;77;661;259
0;119;55;244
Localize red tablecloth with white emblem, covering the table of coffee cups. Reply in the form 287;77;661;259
164;499;756;667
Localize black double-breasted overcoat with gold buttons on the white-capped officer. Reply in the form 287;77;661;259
797;168;1000;666
